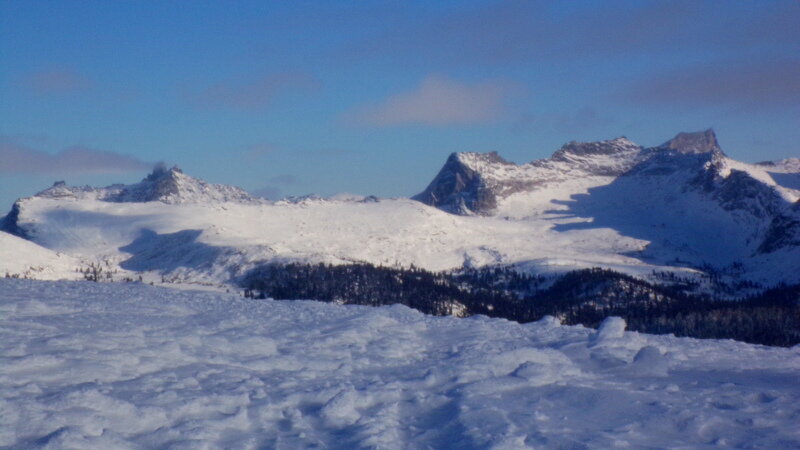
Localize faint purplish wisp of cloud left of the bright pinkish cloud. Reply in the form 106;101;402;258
187;72;320;110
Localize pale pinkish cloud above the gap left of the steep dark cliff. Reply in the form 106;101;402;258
345;76;514;127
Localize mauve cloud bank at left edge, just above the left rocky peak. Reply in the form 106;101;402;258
0;138;153;175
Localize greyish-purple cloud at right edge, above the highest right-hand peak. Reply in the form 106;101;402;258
625;58;800;108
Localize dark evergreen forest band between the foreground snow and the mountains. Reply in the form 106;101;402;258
242;264;800;346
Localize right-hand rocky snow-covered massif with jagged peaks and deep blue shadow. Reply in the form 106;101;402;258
414;130;800;280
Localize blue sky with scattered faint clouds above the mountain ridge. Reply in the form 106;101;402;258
0;0;800;206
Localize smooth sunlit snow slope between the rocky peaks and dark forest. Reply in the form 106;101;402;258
3;192;696;282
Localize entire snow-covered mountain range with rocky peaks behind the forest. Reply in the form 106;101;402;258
2;130;800;285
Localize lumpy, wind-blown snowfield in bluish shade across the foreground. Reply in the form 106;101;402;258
0;280;800;449
